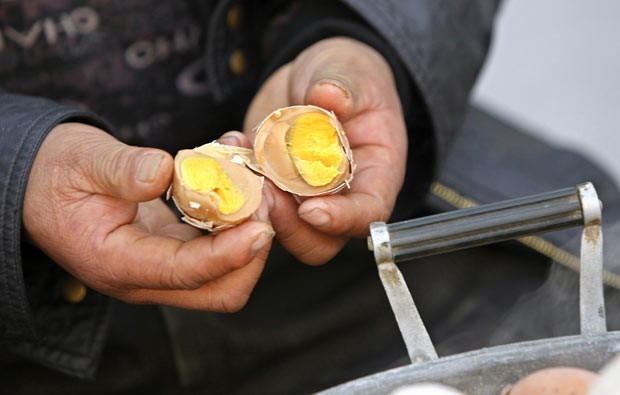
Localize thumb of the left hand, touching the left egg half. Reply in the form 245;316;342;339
67;124;173;202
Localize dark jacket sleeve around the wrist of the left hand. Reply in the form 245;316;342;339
0;90;109;377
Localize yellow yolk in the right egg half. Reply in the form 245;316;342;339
286;113;344;186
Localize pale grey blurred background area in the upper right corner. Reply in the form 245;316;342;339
473;0;620;184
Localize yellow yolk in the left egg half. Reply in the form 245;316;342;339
181;157;245;214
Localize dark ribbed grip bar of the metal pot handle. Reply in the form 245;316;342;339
369;187;583;262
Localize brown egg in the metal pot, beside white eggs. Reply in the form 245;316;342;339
505;366;598;395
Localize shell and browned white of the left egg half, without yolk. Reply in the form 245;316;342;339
168;143;263;231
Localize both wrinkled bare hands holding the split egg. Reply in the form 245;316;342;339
23;38;407;312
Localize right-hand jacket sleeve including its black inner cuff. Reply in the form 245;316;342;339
249;0;498;220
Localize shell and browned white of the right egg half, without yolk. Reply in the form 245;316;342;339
250;106;355;196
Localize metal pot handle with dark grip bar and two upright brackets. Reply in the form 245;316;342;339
368;183;606;363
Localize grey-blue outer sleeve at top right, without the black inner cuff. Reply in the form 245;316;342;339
343;0;499;166
